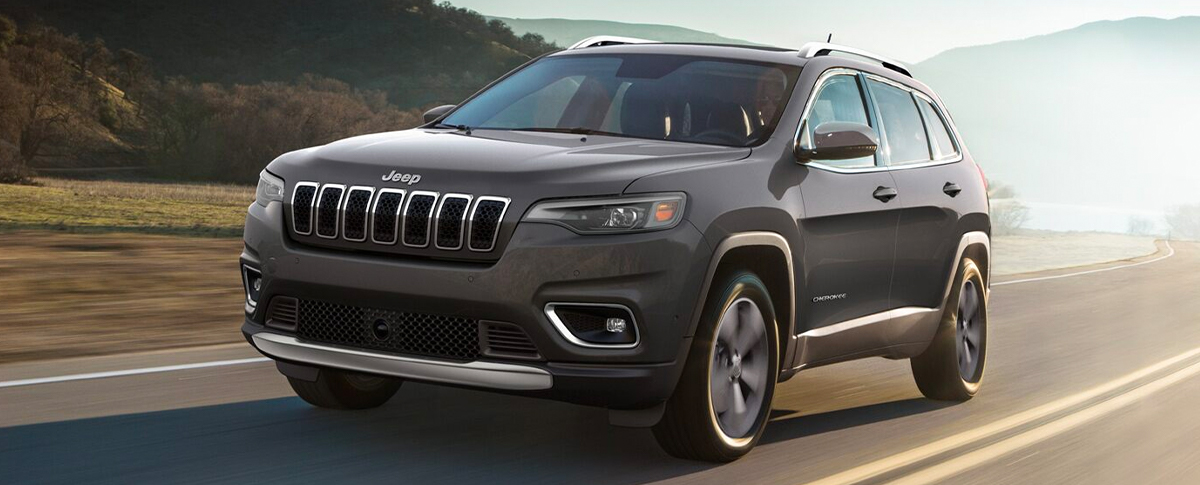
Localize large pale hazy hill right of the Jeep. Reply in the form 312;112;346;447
912;17;1200;227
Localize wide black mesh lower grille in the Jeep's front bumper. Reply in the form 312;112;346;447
296;299;480;360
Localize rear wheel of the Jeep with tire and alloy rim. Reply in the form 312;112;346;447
911;258;988;401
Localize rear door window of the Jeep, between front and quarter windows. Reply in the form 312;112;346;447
868;79;931;164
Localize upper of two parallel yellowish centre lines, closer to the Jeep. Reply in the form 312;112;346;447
809;347;1200;485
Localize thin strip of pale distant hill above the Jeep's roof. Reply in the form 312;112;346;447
488;17;754;47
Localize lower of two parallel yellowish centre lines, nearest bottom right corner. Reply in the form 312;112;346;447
890;357;1200;485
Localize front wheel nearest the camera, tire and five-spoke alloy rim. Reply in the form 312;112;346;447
654;273;779;462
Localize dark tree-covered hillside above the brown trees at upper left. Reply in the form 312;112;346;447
0;0;553;107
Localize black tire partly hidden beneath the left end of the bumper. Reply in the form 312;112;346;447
288;367;403;409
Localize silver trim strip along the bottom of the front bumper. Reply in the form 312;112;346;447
253;333;554;390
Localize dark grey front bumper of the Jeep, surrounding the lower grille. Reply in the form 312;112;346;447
241;203;710;408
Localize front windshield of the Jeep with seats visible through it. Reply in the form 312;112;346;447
443;54;800;146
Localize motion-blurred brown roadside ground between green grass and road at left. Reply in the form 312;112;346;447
0;230;242;364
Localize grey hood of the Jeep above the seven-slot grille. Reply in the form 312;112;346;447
268;128;750;203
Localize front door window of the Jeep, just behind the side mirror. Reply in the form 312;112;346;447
800;74;875;168
